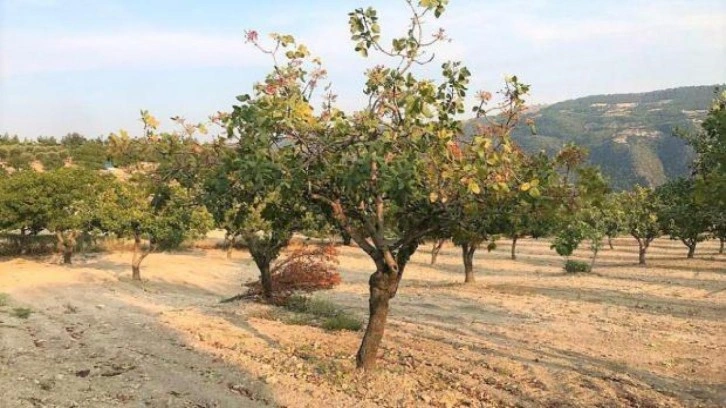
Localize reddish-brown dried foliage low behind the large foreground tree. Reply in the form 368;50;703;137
246;245;341;303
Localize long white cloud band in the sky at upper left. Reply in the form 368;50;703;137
0;30;266;77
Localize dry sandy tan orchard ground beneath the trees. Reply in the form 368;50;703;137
0;238;726;407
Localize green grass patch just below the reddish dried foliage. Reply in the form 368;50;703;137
283;295;363;331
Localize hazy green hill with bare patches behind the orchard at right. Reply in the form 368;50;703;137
506;85;716;190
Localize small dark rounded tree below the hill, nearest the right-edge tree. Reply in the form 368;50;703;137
656;178;713;258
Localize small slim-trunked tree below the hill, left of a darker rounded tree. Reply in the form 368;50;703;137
619;186;661;265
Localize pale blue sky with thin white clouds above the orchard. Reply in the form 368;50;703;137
0;0;726;138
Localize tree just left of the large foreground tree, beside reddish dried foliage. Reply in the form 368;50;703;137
210;84;309;301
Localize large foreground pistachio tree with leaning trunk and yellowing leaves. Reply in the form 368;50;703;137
241;0;526;369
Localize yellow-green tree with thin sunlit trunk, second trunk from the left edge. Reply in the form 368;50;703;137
103;110;213;280
